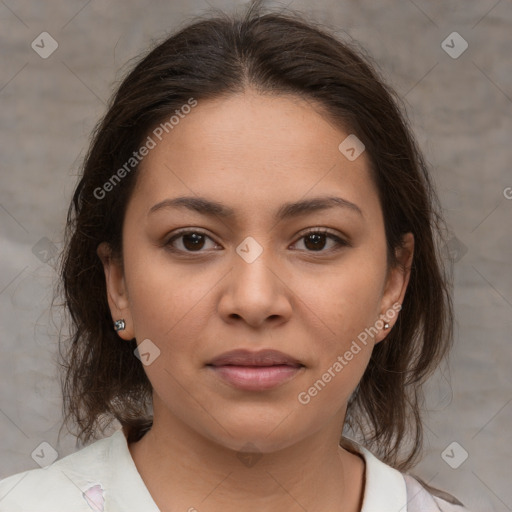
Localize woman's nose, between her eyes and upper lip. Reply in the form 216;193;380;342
218;240;293;328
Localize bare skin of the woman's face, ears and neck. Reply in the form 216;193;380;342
98;89;414;512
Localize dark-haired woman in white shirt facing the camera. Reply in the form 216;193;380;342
0;3;467;512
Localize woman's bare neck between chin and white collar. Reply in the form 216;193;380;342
129;402;364;512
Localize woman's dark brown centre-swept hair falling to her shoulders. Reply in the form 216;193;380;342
59;2;453;470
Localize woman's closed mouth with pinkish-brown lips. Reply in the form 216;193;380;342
206;350;305;391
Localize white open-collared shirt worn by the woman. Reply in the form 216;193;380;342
0;429;468;512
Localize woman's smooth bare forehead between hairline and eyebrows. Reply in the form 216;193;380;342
126;91;378;223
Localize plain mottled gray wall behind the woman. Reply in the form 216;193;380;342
0;0;512;512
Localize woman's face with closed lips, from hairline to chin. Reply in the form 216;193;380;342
98;90;413;452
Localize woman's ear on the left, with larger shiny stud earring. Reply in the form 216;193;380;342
96;242;135;340
